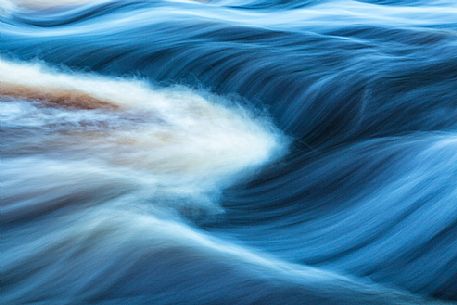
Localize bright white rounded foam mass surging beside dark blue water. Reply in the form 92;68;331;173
0;60;284;197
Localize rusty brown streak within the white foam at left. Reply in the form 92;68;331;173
0;82;119;110
